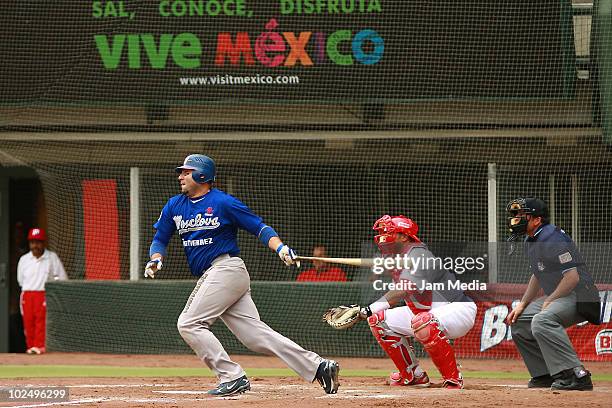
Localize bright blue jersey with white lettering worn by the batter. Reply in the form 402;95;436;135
153;188;269;276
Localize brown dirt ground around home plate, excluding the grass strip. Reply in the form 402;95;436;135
0;353;612;408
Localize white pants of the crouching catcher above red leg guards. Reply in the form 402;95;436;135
385;302;476;339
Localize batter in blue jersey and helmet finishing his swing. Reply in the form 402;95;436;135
145;154;340;396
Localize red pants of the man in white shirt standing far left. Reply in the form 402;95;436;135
21;290;47;349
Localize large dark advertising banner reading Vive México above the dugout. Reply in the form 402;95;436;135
0;0;573;104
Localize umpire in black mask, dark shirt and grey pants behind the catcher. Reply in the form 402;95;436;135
506;198;599;391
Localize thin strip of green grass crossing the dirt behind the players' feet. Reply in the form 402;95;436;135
0;365;612;381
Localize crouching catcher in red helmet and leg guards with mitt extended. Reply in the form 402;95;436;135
323;215;476;389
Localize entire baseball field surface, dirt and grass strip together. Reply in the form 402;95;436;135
0;353;612;408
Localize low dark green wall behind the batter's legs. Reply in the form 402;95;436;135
47;280;382;357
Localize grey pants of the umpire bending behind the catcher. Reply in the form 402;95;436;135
512;292;585;377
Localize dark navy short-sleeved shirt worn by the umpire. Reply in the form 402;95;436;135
525;224;593;295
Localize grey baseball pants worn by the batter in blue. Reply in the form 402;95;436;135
177;255;323;383
